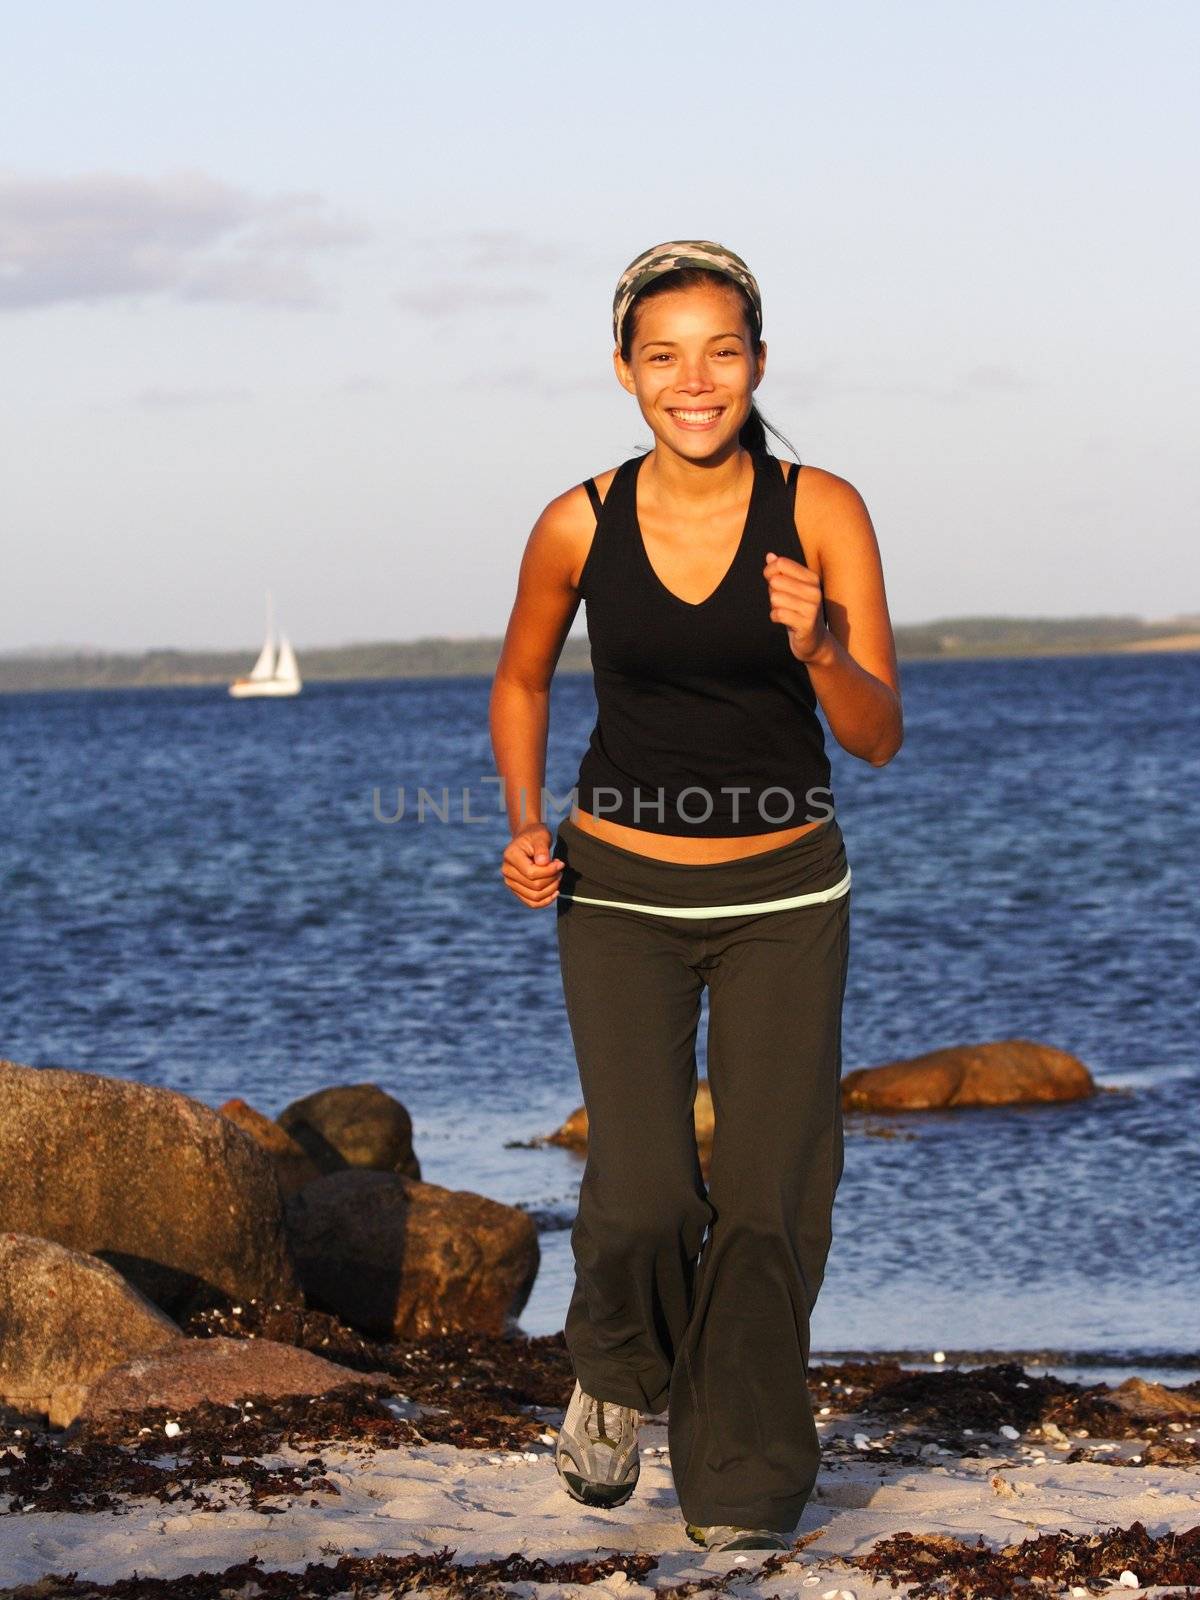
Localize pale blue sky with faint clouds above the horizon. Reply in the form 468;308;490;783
0;0;1200;649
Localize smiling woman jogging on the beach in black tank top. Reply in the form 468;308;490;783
491;240;902;1550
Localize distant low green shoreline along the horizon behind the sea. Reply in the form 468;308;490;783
0;614;1200;693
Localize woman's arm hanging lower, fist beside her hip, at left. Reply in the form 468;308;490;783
488;488;595;906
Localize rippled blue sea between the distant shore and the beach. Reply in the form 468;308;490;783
0;654;1200;1381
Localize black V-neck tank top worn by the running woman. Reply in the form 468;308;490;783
576;451;834;838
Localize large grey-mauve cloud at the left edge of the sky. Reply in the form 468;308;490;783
0;171;366;310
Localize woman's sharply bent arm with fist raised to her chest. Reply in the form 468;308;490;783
763;467;904;766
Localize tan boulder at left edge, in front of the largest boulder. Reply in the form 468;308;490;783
0;1234;182;1427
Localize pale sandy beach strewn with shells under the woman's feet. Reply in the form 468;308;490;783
0;1400;1200;1600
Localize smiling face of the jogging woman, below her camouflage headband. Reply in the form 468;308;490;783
613;282;766;461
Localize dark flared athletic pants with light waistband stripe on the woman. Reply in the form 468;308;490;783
554;818;850;1534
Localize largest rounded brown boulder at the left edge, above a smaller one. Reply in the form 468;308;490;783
0;1061;301;1322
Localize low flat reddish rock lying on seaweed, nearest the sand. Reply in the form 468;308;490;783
78;1338;395;1421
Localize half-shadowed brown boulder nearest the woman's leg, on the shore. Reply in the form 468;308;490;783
286;1171;539;1339
